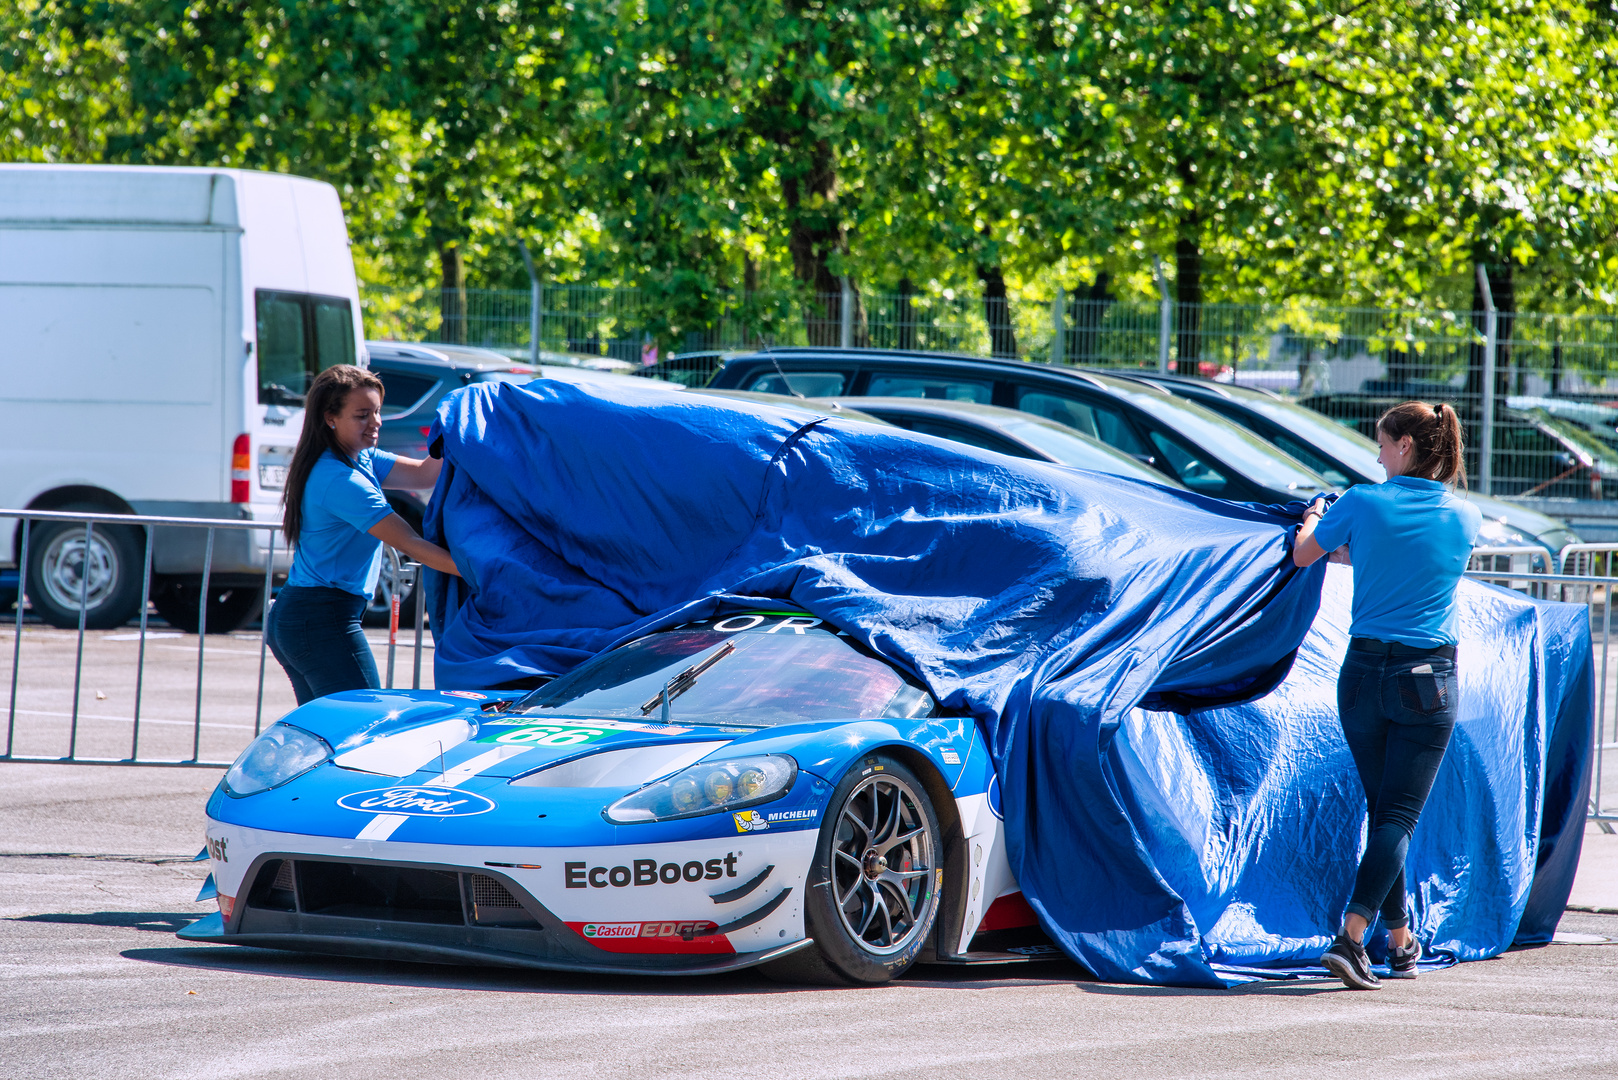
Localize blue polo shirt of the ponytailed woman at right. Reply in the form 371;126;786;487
1314;476;1484;648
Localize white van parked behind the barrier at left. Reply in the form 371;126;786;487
0;165;364;630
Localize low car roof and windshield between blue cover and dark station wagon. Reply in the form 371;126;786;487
828;397;1183;487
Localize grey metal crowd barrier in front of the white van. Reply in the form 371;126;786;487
0;510;426;767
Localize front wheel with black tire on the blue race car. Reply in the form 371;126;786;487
760;753;943;986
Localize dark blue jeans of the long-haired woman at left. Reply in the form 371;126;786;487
264;586;382;704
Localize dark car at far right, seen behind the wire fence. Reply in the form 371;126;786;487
1299;393;1618;499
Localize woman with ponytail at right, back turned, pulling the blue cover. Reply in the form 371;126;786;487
1293;402;1482;989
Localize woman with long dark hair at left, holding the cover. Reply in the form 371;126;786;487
265;364;460;704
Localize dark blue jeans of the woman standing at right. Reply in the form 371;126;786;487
1336;648;1458;929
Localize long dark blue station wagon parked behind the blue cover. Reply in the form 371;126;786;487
710;348;1333;502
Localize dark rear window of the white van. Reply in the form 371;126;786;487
254;288;354;408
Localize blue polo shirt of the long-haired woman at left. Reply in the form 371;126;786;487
286;450;395;599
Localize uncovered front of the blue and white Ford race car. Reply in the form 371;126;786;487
181;606;1035;984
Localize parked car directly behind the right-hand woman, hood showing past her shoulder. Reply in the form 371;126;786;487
1136;372;1579;555
